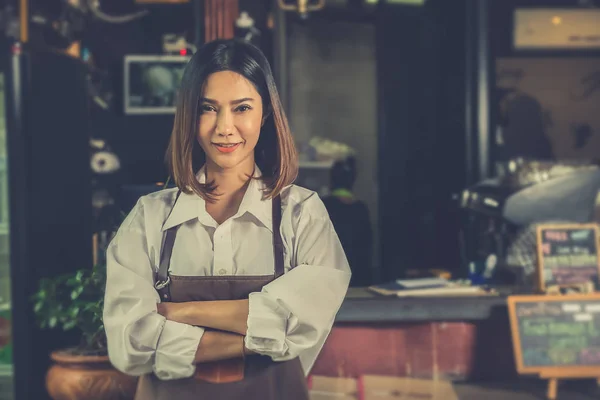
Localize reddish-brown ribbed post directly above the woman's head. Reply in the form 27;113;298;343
204;0;239;42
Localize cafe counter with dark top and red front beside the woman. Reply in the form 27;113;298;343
311;288;516;381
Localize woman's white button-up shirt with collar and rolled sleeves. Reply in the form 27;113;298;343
104;167;350;379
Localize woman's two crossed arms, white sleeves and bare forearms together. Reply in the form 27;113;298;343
103;197;350;379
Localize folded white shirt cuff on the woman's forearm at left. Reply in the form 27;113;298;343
154;320;204;380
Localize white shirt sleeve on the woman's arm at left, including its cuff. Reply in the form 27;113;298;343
103;201;204;379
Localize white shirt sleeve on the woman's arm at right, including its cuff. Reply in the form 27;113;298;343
245;195;351;374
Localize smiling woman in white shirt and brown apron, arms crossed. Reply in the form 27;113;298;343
104;41;350;400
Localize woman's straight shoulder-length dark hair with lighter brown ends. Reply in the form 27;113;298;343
166;39;298;201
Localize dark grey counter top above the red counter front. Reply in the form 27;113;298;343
336;288;506;322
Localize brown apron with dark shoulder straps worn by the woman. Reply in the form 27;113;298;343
135;194;309;400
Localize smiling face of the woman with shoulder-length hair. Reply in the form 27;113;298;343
198;71;263;173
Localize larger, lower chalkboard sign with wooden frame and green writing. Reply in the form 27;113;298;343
508;294;600;376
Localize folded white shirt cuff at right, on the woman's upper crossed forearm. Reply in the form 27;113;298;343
245;292;290;357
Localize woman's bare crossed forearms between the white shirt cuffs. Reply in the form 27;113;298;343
157;300;251;363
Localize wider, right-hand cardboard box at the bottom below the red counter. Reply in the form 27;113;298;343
359;375;458;400
